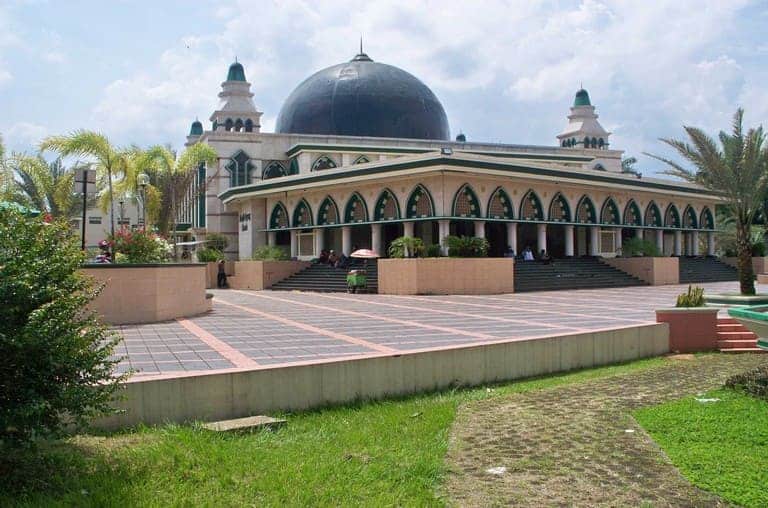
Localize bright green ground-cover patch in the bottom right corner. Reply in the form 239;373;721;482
635;389;768;507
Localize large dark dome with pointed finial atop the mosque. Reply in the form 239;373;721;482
275;53;450;140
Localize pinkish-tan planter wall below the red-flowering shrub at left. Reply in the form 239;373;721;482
83;263;211;325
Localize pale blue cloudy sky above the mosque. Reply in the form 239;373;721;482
0;0;768;174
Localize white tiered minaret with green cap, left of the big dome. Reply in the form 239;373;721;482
211;60;262;132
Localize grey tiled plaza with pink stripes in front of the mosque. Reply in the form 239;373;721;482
116;282;738;376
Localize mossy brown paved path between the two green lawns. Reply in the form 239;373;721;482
446;355;765;506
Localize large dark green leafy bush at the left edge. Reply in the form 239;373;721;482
0;209;124;446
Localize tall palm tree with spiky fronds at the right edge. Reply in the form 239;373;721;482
646;108;768;295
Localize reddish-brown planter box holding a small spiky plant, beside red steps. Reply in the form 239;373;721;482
656;307;718;353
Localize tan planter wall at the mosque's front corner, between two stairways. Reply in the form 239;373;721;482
378;258;515;295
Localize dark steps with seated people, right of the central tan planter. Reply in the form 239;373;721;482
515;258;647;293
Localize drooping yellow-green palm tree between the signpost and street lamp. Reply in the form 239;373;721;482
40;130;129;241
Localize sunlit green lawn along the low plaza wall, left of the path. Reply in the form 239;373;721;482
0;358;665;506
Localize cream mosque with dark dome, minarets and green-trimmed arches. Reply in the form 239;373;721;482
180;48;717;259
